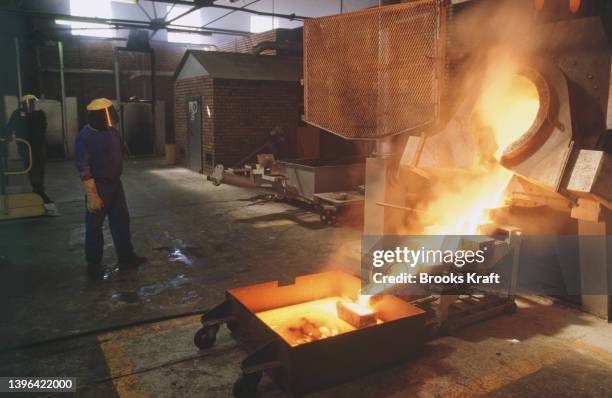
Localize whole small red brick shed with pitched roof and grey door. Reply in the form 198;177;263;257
174;50;303;172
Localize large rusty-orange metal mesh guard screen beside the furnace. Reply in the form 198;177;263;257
304;0;438;139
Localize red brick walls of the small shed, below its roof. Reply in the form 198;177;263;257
174;77;303;172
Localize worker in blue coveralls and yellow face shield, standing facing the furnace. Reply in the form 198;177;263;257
75;98;147;279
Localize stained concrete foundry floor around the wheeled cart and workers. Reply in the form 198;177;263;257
0;160;612;397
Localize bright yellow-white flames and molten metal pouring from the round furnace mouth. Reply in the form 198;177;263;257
419;56;540;235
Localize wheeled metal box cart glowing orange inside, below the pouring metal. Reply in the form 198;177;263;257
194;271;426;398
